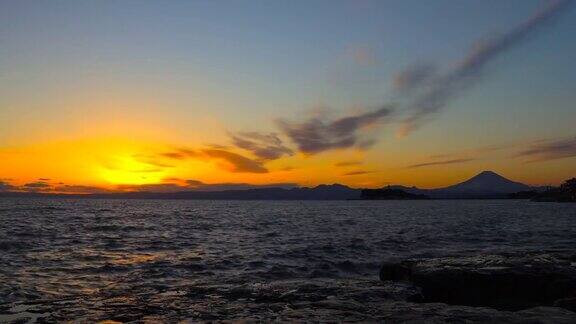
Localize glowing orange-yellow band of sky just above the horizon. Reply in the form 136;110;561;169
0;137;572;193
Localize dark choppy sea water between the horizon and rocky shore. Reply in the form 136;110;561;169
0;199;576;322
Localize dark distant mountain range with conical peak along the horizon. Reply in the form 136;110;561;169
0;171;540;200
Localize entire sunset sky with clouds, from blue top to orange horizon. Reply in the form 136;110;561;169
0;0;576;193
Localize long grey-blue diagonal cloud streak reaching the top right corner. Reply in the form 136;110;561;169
394;0;572;136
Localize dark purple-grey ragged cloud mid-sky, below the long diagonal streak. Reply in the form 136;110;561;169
277;106;392;154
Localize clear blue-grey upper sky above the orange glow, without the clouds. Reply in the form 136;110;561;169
0;0;576;189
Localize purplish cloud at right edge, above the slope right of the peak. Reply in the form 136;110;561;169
516;137;576;162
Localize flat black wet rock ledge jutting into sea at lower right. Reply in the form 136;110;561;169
380;253;576;311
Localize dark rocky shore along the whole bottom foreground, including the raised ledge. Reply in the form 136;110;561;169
0;253;576;323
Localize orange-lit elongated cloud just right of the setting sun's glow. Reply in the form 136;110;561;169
160;148;268;173
